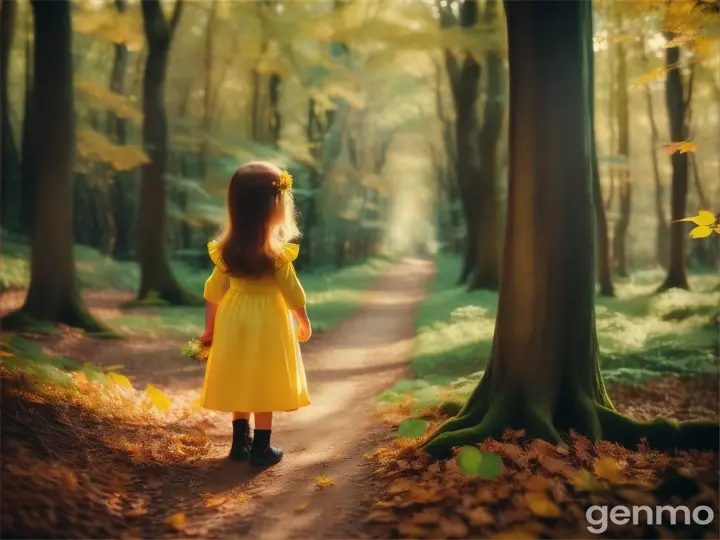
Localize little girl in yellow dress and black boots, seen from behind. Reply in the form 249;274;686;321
200;162;312;466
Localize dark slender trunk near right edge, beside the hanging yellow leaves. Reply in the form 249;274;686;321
658;35;690;292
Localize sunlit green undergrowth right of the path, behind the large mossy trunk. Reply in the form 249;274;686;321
386;254;720;409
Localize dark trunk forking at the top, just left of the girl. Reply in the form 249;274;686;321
138;0;195;305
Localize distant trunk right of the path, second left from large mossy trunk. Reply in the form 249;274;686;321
440;0;481;284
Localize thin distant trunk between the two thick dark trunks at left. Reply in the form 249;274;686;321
107;0;135;259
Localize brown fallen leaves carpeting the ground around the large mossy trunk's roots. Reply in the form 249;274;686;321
366;377;720;539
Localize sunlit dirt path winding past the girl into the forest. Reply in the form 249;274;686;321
6;260;433;540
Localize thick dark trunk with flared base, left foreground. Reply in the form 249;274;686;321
3;0;103;331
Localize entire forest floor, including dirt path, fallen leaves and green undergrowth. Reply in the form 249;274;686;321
0;255;720;539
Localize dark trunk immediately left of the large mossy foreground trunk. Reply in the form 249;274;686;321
470;0;505;290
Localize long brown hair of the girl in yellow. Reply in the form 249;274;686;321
218;161;300;278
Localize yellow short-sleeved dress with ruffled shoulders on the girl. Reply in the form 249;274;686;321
200;241;310;412
